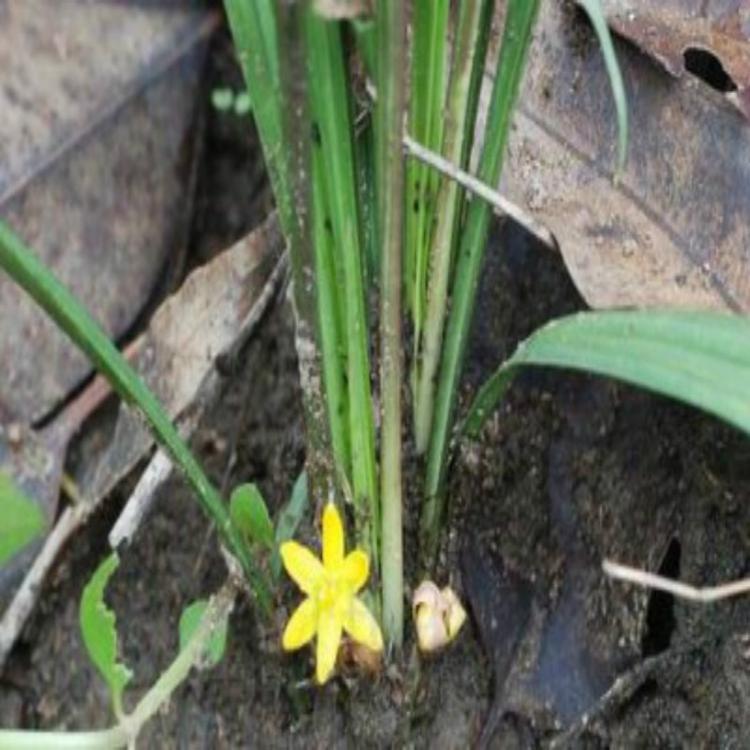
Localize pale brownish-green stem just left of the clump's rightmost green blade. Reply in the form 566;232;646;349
414;0;493;453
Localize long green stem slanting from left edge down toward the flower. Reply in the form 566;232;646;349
0;222;271;614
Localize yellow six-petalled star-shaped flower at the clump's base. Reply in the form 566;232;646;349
281;503;383;684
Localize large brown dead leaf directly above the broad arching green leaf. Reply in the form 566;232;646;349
483;3;750;312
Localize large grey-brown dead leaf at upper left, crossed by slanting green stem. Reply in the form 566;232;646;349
0;0;215;423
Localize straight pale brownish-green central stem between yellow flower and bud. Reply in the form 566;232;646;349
376;0;406;648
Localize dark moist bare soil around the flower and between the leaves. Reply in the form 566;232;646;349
0;23;750;748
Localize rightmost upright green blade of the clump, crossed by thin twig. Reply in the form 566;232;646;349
421;0;539;566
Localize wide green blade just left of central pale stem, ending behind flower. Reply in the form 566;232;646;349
305;10;379;559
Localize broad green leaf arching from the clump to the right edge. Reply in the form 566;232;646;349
465;311;750;434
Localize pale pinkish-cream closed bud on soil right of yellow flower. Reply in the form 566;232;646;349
412;581;466;654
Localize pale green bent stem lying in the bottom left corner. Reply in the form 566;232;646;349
0;581;237;750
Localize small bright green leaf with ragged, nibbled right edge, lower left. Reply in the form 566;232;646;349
79;552;133;716
